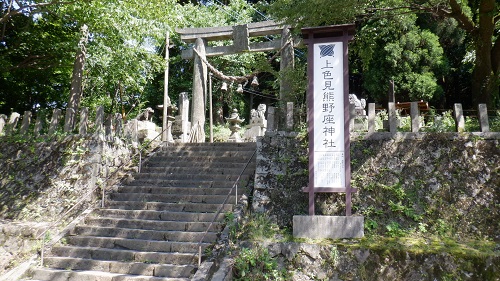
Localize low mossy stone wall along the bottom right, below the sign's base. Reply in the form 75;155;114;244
241;238;500;281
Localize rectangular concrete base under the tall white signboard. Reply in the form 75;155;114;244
293;216;364;239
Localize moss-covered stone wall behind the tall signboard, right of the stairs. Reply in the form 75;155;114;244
252;132;500;240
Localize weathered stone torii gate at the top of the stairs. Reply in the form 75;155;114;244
176;21;294;142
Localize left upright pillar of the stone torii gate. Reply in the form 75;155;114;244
191;38;208;142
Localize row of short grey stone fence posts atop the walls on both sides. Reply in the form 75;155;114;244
0;102;500;141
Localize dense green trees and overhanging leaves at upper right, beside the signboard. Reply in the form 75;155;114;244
268;0;500;107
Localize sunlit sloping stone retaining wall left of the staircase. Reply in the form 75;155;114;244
0;135;145;275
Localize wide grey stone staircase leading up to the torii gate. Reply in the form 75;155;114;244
25;143;256;281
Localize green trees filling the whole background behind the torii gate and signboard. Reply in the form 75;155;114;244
0;0;500;116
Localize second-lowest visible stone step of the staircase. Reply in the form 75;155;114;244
44;257;196;278
